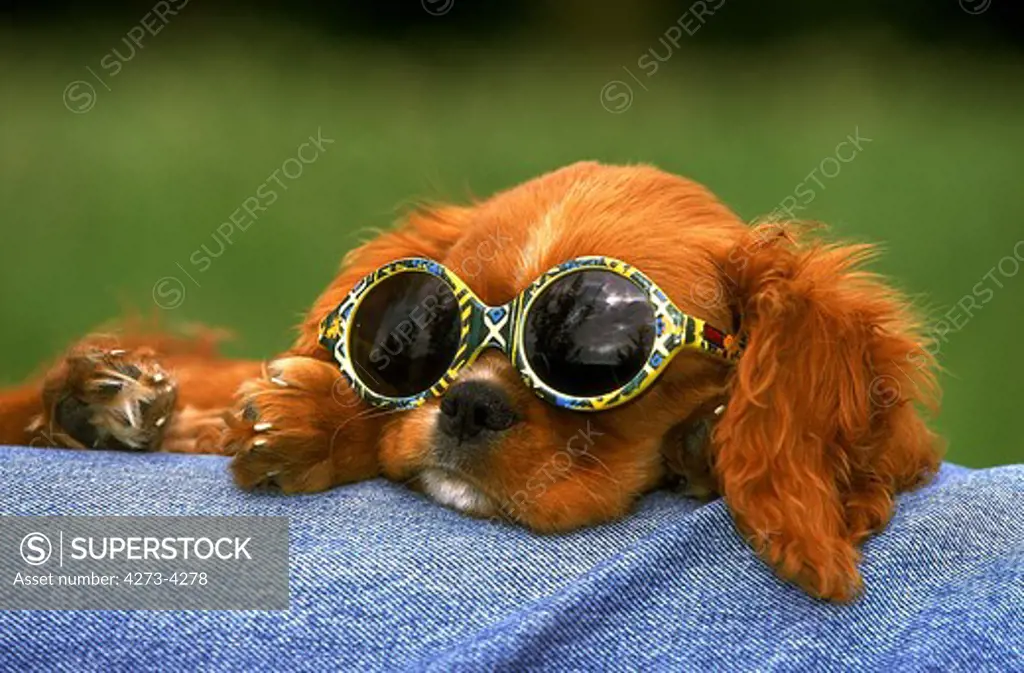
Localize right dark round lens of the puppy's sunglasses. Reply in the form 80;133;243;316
523;270;654;397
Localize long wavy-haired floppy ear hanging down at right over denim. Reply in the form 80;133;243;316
714;224;939;600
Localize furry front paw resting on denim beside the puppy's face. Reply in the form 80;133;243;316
222;357;350;493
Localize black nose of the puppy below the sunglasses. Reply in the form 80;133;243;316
440;381;518;441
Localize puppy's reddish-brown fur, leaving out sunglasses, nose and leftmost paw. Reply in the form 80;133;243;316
0;163;939;600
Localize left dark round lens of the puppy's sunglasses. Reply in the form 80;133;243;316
348;271;460;397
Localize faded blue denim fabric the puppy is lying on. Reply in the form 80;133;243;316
0;449;1024;671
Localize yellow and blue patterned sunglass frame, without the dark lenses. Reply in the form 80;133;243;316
319;256;742;411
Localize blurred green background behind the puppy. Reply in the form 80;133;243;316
0;0;1024;466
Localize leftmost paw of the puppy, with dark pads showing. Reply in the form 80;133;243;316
29;341;177;451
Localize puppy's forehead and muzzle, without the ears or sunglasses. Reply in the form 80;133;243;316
366;164;745;531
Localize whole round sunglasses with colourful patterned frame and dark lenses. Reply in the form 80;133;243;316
319;257;742;411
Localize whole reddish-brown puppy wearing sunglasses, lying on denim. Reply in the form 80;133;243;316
0;163;940;601
